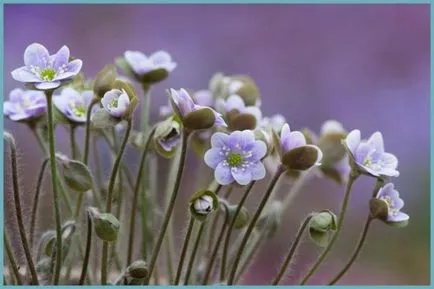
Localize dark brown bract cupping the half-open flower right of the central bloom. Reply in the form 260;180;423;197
282;145;321;171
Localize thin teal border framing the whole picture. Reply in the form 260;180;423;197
0;0;434;289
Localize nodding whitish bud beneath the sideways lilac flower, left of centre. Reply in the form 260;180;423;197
153;117;181;158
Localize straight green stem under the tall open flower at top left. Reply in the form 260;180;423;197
45;90;63;285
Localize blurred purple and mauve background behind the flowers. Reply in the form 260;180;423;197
4;4;430;284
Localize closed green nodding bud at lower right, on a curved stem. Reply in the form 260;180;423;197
309;210;337;247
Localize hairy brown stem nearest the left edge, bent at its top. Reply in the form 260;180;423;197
4;133;39;285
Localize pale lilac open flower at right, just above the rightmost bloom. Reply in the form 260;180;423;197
345;130;399;177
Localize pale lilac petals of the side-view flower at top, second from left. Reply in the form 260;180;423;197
124;50;177;76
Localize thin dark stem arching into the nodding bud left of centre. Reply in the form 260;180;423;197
127;128;155;264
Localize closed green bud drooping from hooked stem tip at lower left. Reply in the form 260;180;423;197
88;207;120;242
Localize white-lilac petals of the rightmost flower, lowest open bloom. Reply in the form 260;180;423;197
376;183;410;222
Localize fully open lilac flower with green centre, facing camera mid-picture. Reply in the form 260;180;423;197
204;130;267;185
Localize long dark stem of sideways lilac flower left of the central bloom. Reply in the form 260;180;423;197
145;130;189;285
